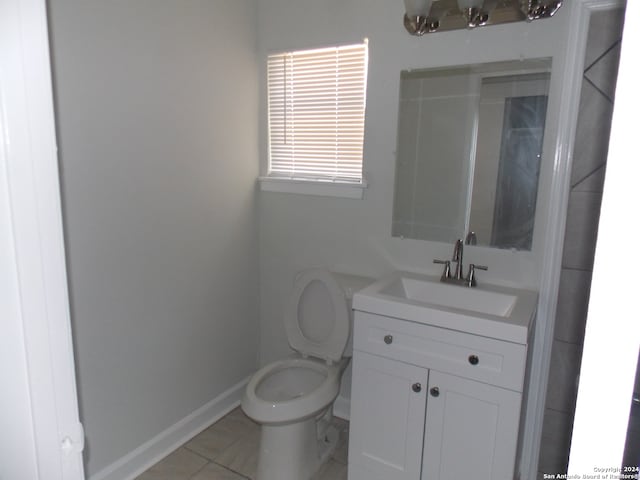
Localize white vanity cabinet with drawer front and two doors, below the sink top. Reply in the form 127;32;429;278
349;311;527;480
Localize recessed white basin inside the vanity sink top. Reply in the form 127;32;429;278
380;276;518;317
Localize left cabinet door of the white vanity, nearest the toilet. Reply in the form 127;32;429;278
349;352;428;480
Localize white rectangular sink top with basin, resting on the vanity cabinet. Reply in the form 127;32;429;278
353;272;538;344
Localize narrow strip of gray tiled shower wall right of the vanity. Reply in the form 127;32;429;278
538;6;624;478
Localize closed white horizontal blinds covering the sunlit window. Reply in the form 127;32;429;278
267;42;368;183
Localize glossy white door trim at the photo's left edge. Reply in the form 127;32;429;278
0;0;84;480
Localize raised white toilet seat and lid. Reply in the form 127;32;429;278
284;269;351;362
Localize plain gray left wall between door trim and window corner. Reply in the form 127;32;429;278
49;0;258;475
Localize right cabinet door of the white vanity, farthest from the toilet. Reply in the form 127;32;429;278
422;370;521;480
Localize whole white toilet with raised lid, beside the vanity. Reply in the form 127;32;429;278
242;269;372;480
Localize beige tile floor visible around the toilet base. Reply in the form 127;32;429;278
136;408;349;480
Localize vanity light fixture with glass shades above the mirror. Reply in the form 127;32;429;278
404;0;563;36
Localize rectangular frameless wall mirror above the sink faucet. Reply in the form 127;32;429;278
392;59;551;250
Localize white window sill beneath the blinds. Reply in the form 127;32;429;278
258;177;367;199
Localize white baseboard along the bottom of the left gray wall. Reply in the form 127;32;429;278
89;377;250;480
